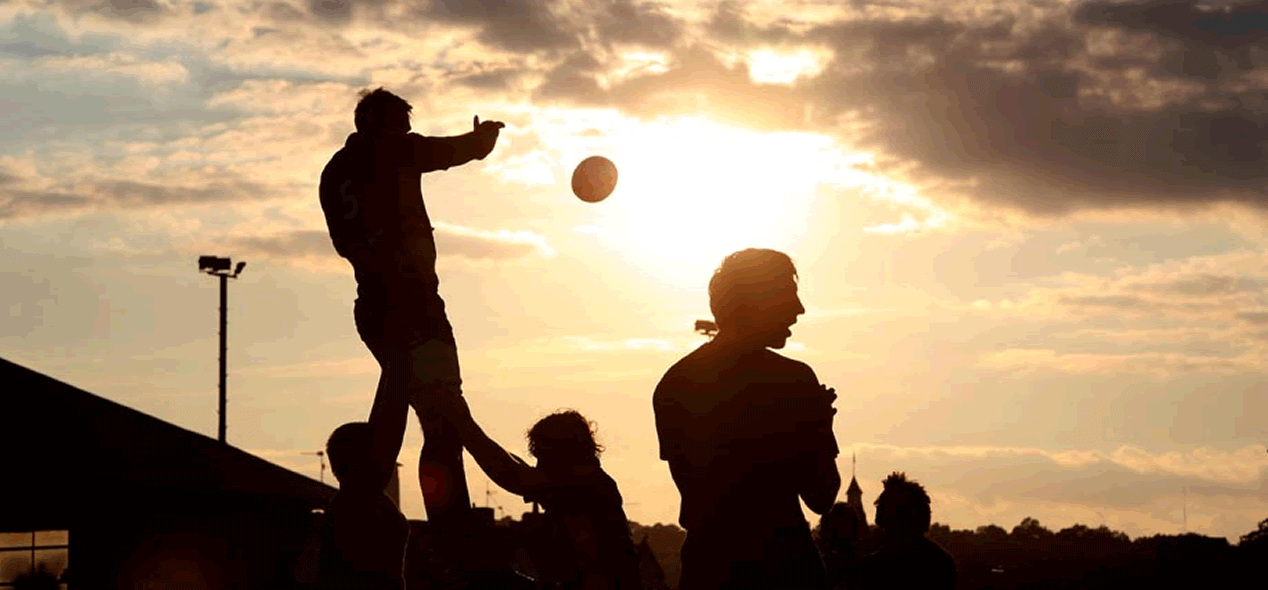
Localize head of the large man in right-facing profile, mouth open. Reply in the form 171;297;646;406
709;247;805;348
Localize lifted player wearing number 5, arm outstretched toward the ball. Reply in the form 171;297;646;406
321;88;503;529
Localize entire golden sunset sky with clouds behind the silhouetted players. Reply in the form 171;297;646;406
0;0;1268;539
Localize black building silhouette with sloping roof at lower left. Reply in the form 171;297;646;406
0;359;335;589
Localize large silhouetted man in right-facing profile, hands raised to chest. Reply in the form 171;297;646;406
653;249;841;590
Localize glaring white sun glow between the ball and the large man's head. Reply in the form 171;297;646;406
575;118;839;287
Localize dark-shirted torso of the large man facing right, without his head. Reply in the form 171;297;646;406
654;343;824;589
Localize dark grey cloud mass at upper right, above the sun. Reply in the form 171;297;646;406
502;3;1268;216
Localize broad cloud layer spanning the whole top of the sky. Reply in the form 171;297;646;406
16;0;1268;223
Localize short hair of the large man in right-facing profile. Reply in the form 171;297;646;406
709;247;796;326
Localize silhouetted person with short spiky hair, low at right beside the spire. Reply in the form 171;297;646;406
860;473;956;590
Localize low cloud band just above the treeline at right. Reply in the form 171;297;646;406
838;435;1268;538
